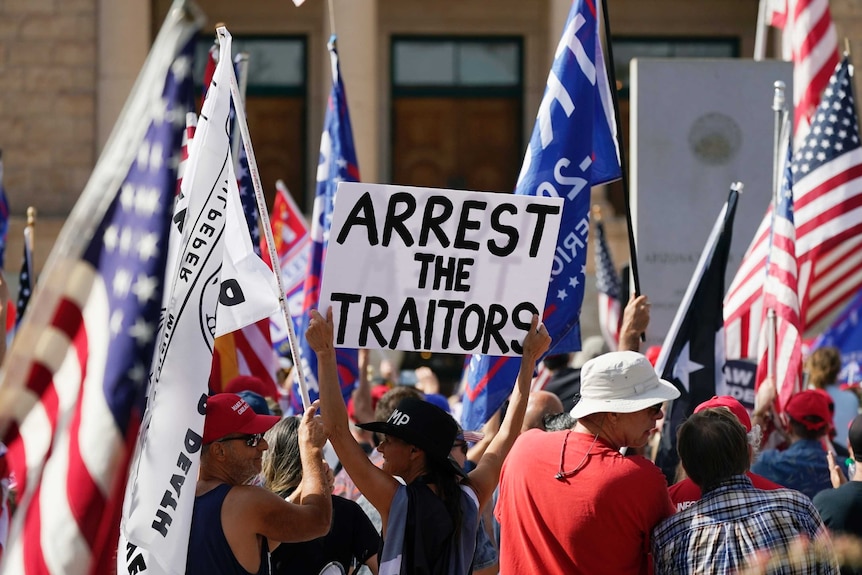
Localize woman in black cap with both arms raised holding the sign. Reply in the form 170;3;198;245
305;309;551;575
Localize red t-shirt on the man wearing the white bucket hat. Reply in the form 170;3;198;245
494;430;673;575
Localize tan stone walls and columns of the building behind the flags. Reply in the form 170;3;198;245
0;0;862;342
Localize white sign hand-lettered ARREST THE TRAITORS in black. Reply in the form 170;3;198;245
320;182;564;355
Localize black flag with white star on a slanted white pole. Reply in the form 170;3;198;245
655;185;739;482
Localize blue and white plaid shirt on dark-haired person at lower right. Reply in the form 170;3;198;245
652;475;838;575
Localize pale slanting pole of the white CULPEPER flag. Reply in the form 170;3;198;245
223;27;311;409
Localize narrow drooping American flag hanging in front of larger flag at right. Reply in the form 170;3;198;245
756;123;802;409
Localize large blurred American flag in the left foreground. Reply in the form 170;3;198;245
0;5;197;574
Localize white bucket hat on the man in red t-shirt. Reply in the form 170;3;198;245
569;351;679;419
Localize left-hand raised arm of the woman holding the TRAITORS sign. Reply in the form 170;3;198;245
305;308;399;525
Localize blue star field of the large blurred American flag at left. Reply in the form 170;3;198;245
83;42;193;433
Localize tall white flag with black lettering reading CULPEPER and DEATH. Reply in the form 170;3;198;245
118;27;277;574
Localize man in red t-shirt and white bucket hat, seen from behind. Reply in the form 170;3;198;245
495;351;679;575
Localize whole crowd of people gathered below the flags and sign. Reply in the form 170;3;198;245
182;296;862;575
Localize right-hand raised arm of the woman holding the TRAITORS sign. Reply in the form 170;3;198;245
469;315;551;509
